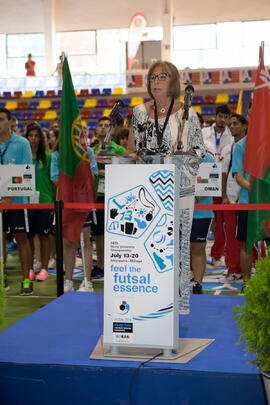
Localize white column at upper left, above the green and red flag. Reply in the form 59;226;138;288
43;0;56;76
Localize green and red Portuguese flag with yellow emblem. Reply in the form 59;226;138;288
58;58;96;243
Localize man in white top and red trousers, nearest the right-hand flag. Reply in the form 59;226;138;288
221;114;248;283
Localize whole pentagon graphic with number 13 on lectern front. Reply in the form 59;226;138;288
106;185;160;239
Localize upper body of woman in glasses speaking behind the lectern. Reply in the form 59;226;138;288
128;61;206;158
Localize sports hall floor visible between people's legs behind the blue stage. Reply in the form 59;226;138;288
0;241;242;332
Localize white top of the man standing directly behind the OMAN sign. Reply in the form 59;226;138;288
202;124;234;162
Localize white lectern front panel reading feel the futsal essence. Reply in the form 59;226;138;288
104;164;179;349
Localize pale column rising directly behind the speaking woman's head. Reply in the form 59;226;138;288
161;0;173;62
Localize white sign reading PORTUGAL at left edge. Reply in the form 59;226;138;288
0;165;36;197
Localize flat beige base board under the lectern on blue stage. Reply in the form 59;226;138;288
89;336;215;364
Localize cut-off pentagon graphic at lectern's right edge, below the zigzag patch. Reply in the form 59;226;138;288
144;214;174;273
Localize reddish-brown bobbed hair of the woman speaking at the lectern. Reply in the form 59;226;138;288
147;60;180;99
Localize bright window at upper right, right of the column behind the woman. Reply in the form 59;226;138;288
172;21;270;69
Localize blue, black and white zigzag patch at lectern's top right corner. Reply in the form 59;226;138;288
149;170;174;211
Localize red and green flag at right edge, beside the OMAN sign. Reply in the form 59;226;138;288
244;47;270;252
